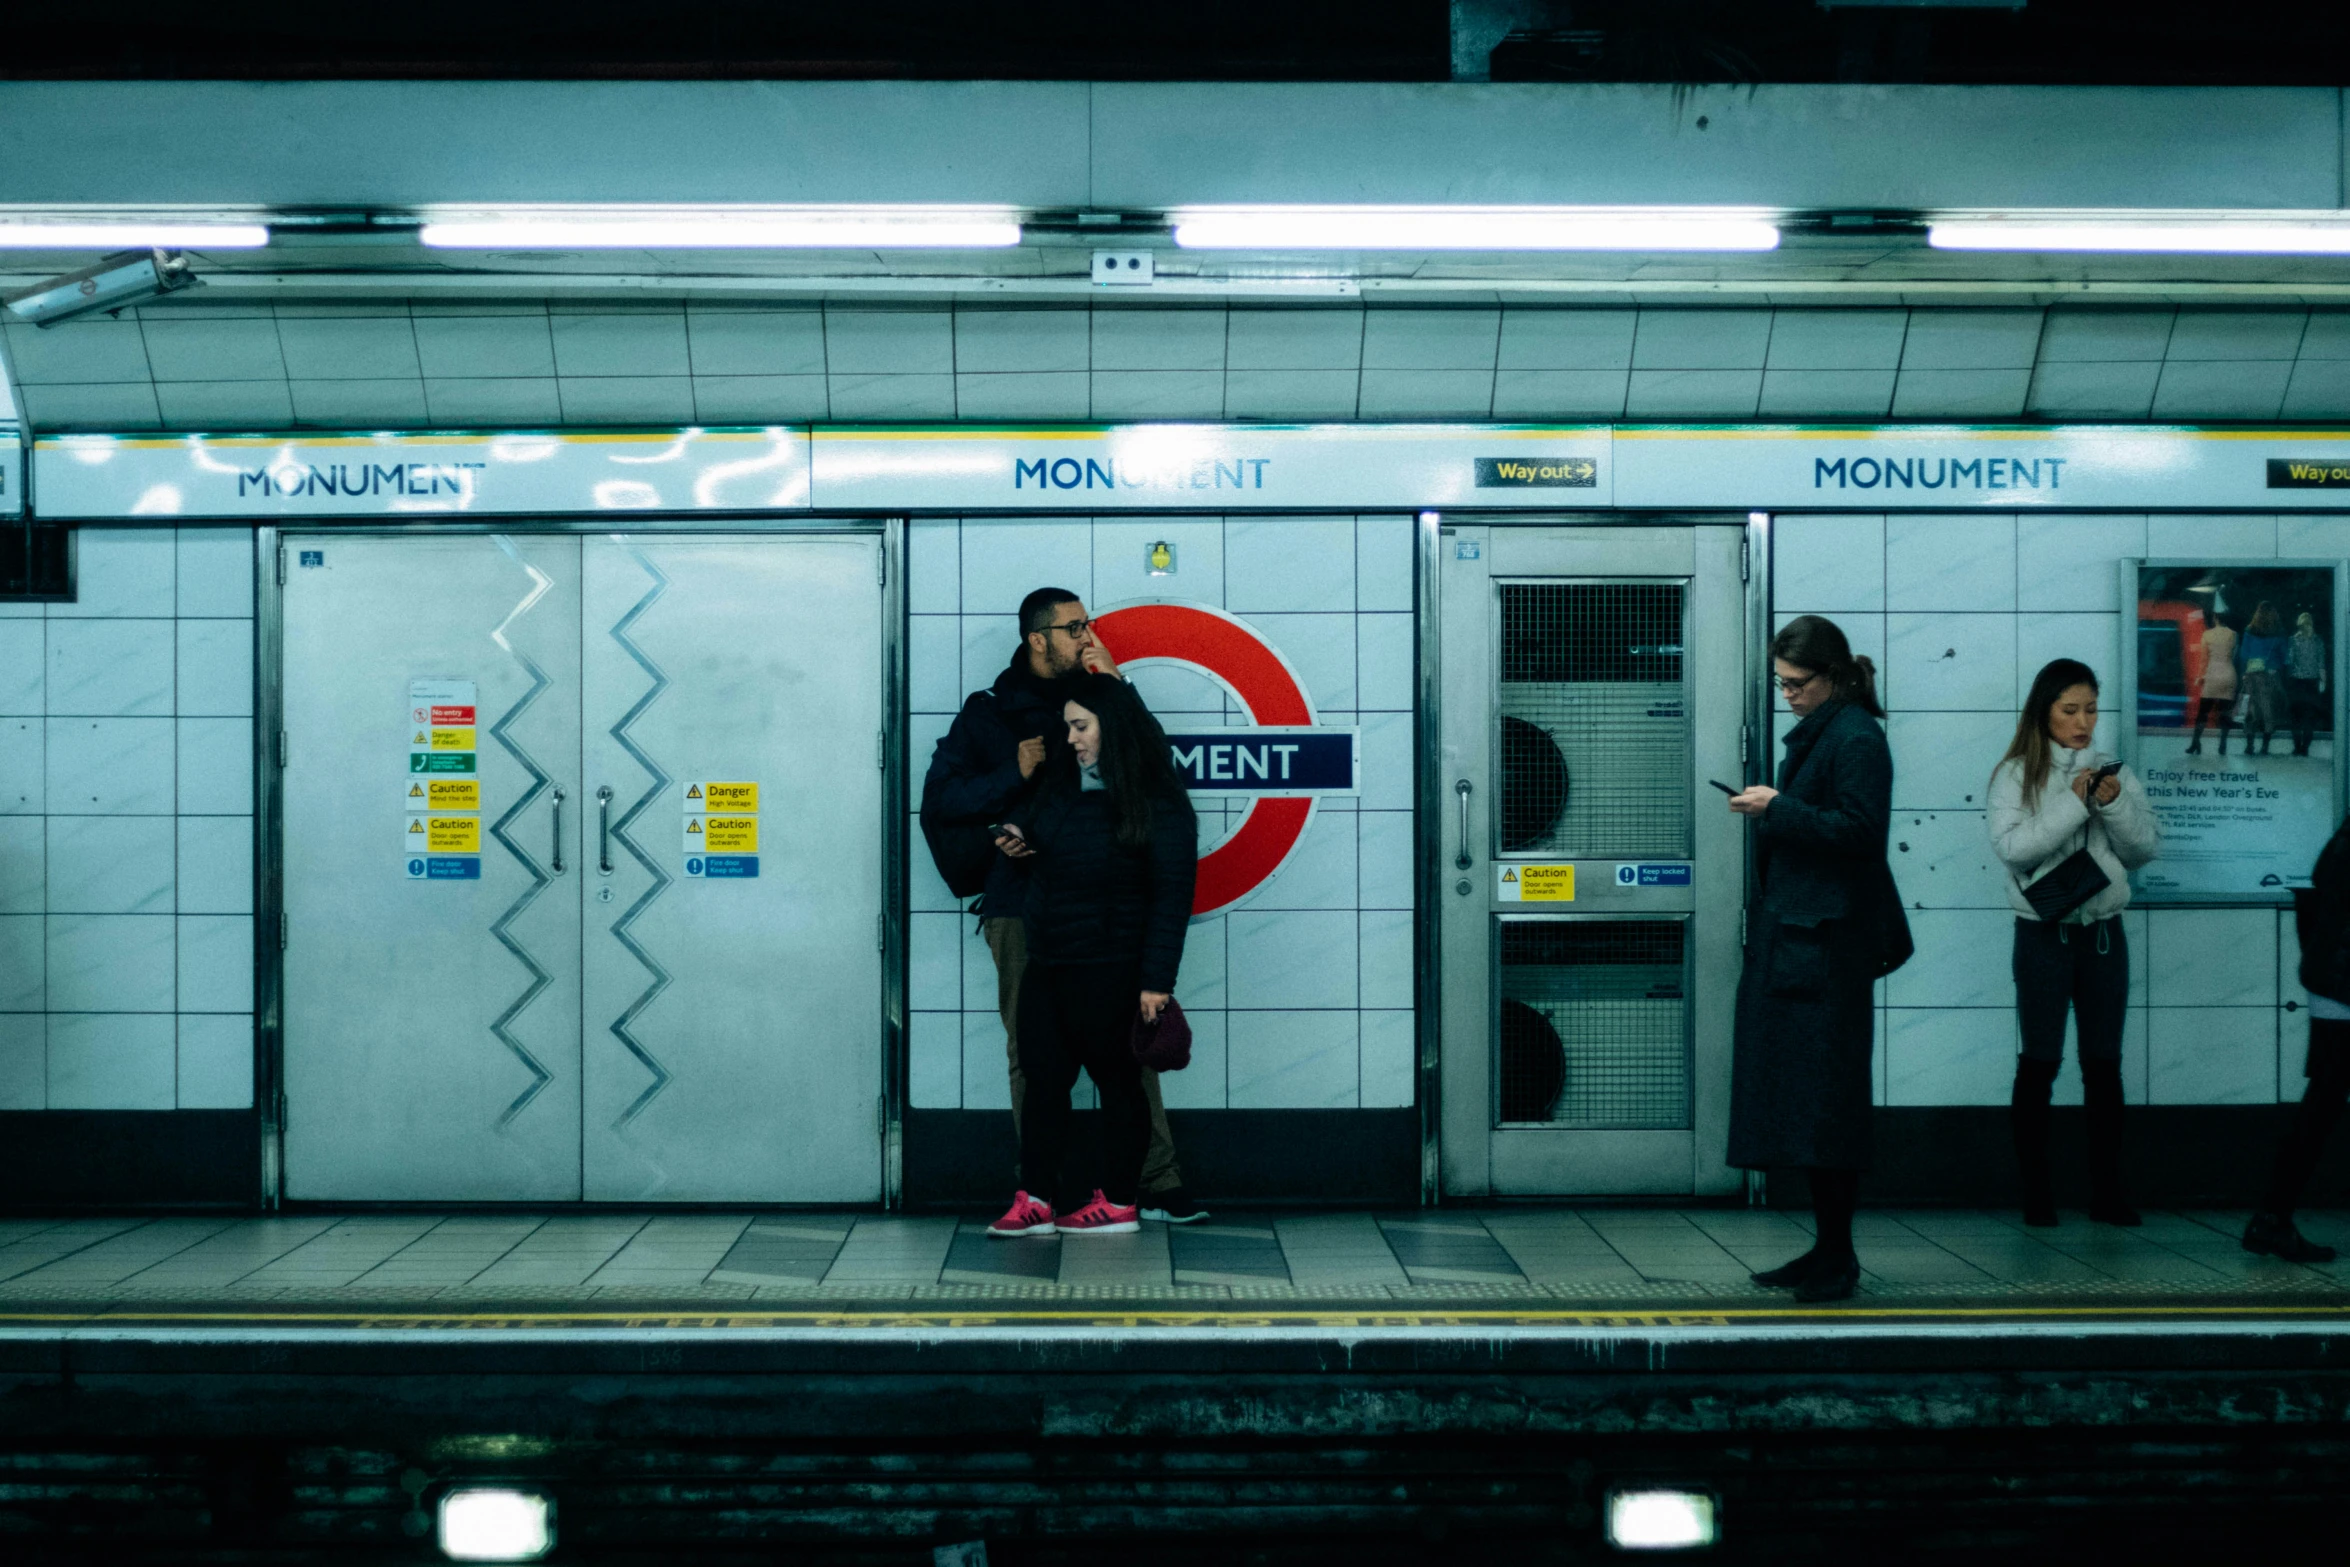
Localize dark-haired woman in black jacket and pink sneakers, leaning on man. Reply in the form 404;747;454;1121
987;674;1199;1236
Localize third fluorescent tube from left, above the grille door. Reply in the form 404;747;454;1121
1175;207;1779;251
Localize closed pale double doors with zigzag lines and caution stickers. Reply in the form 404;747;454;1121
280;533;886;1203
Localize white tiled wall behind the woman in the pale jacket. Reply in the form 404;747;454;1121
1772;512;2293;1104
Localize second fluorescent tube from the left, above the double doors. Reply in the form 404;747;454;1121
418;211;1020;251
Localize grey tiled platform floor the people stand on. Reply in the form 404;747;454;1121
0;1208;2350;1316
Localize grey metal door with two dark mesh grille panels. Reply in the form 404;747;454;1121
1438;522;1748;1196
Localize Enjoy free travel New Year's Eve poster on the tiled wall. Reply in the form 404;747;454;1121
2131;561;2341;902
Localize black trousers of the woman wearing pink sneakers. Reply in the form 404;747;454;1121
1020;963;1152;1212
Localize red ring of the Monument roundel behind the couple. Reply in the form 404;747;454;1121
1093;604;1314;916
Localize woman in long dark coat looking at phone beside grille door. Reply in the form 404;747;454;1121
1730;616;1911;1302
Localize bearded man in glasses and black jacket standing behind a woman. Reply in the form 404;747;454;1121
921;587;1208;1224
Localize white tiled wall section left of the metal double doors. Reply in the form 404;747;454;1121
0;529;254;1109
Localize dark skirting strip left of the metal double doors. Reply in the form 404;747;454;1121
0;1109;261;1212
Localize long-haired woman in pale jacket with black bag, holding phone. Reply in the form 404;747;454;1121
1988;658;2162;1226
